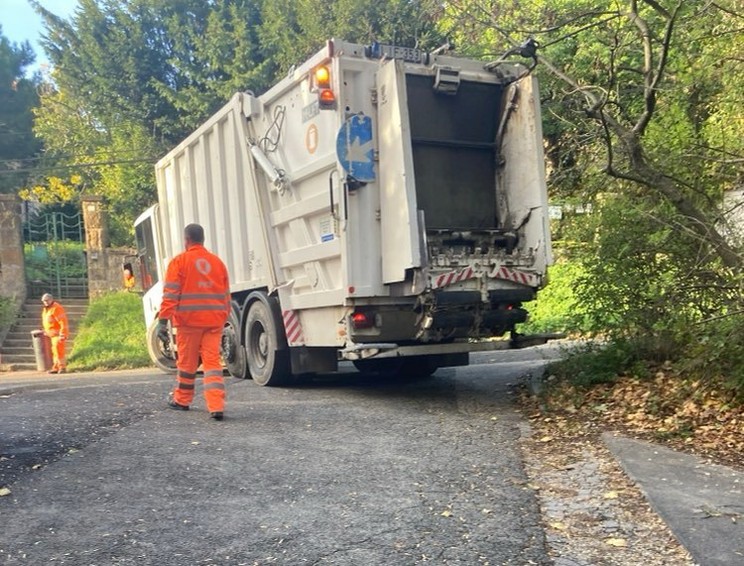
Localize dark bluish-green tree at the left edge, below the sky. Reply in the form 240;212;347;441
0;27;41;193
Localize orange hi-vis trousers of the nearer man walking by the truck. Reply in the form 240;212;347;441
173;326;225;413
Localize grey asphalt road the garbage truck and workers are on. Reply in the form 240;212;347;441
0;349;551;566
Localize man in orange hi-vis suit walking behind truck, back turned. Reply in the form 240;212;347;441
158;224;230;421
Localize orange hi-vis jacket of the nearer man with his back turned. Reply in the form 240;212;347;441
159;244;230;328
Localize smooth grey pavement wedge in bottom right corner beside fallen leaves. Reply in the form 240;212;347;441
602;433;744;566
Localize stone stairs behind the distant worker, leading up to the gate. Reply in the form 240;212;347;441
0;299;88;371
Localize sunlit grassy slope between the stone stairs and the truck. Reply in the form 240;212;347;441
68;292;151;371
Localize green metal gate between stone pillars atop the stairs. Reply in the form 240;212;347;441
23;209;88;299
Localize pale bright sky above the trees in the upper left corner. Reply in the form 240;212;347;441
0;0;78;74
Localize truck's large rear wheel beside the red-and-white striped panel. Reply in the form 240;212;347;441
244;293;292;386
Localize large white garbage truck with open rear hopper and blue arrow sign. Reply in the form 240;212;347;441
135;40;552;386
